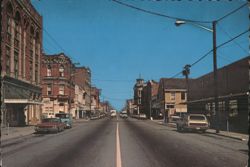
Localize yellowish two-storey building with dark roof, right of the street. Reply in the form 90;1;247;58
158;78;187;119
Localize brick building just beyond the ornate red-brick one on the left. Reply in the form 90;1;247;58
74;67;91;118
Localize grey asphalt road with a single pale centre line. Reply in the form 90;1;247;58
2;118;248;167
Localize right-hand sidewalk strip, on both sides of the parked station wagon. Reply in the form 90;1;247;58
152;120;249;141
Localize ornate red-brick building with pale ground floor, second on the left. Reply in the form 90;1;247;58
41;53;75;117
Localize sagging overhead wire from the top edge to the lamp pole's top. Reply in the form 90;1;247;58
112;0;212;23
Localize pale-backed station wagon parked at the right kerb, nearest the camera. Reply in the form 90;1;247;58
176;114;209;132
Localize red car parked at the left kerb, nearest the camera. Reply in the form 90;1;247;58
35;118;65;133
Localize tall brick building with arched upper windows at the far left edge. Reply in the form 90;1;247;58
1;0;42;126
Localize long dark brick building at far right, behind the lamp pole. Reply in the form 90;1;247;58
188;56;250;133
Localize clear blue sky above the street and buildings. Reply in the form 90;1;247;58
31;0;250;109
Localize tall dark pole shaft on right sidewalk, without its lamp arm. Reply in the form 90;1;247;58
213;21;220;133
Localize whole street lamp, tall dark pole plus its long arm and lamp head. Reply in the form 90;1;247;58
175;20;220;133
